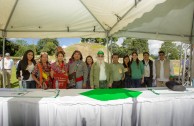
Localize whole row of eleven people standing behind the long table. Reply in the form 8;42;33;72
0;47;174;89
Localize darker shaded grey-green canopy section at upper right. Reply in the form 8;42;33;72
115;0;194;85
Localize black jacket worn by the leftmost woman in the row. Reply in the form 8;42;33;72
16;60;36;80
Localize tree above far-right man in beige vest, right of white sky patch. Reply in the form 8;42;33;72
160;41;181;60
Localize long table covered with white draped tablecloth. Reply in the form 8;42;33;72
0;87;194;126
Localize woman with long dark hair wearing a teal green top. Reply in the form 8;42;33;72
131;52;144;88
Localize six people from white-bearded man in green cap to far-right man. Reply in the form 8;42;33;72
90;51;174;88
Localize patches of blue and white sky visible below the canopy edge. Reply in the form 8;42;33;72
9;38;163;55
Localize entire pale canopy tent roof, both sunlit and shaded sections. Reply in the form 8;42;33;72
0;0;194;87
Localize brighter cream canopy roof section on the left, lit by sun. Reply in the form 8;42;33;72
0;0;165;38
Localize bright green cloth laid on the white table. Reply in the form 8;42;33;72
80;88;142;101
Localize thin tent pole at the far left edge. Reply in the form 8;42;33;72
2;31;6;88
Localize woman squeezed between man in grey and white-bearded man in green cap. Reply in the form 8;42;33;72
85;55;94;89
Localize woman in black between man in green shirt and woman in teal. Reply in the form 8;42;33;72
123;55;132;88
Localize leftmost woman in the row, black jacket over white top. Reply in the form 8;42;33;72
16;50;36;88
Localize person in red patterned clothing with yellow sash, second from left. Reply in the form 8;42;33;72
32;52;52;89
